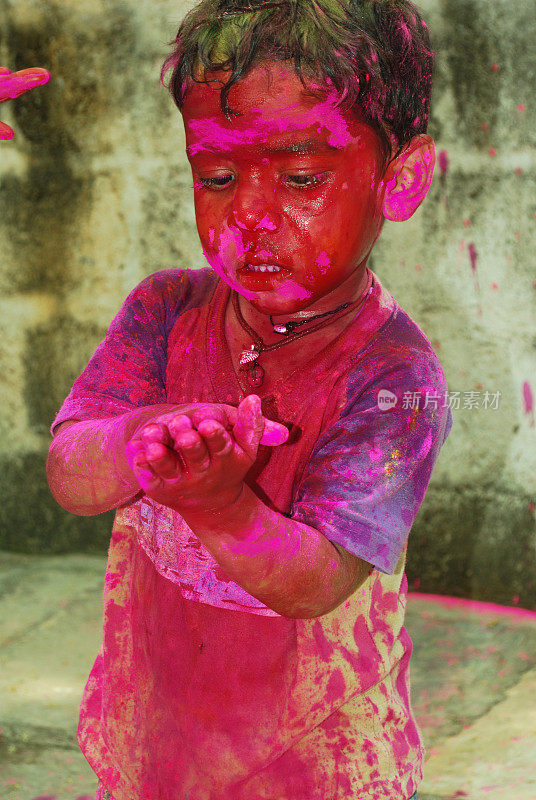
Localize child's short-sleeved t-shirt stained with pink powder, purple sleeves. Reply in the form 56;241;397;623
51;268;452;800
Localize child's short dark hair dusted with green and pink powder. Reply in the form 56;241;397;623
160;0;435;175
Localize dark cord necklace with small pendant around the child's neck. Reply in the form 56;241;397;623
232;275;374;388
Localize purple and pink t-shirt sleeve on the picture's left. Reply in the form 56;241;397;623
50;269;187;435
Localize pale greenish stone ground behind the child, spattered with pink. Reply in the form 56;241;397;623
0;552;536;800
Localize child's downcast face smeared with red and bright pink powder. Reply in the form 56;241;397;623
183;62;383;314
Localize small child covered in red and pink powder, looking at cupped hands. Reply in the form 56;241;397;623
47;0;452;800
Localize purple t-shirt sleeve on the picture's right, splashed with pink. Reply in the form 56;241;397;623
291;353;452;575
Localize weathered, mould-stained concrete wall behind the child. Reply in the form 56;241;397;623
0;0;536;608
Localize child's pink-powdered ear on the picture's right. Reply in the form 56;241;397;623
382;133;436;222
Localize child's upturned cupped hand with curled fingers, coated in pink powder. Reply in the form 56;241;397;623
126;395;288;512
